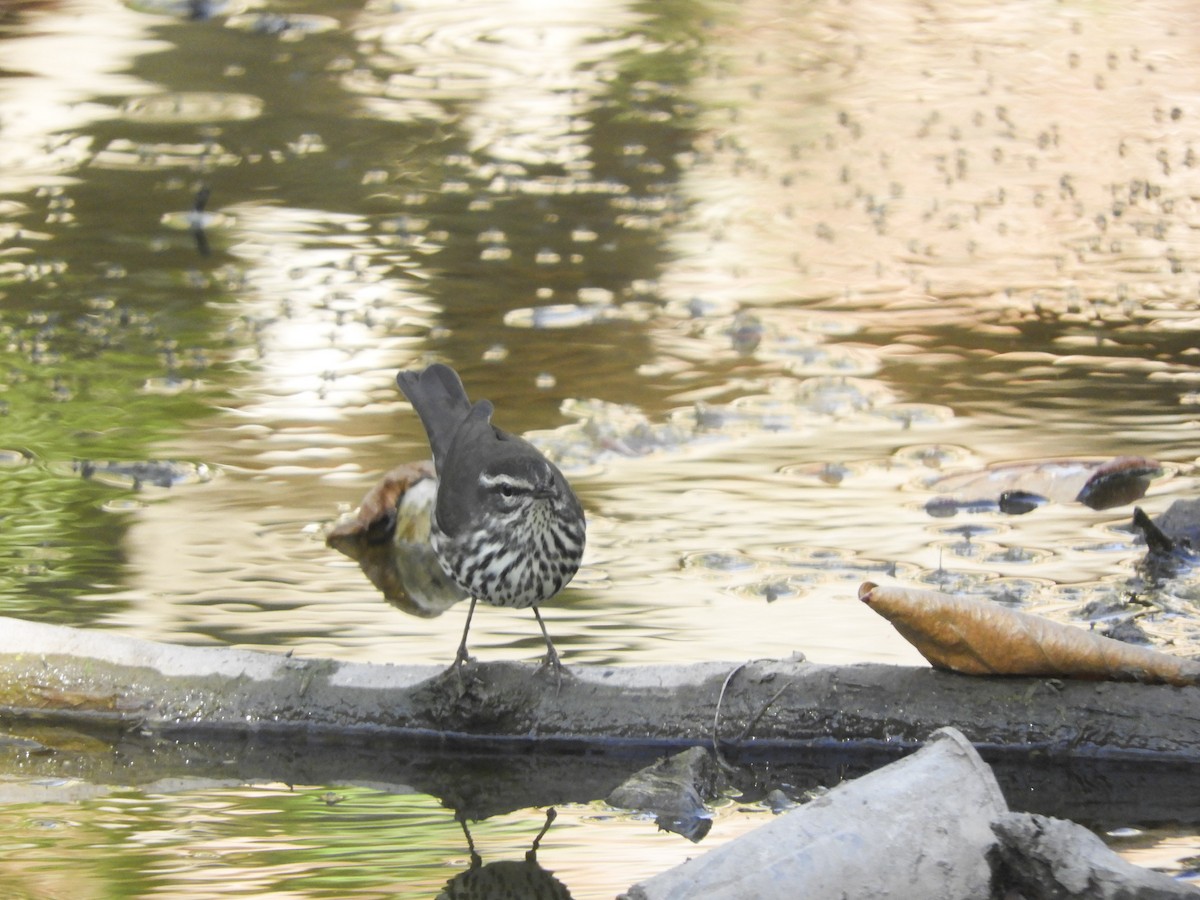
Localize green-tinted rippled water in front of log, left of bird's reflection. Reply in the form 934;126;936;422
0;785;472;898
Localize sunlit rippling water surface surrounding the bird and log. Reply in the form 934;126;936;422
0;0;1200;896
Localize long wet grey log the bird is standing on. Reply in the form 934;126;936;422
0;618;1200;762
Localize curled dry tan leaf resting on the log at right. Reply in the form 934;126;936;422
858;582;1200;685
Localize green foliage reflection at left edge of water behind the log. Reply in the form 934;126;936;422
0;251;226;624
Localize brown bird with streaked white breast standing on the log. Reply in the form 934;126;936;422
396;362;587;674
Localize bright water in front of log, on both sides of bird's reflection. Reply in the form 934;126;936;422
0;782;768;900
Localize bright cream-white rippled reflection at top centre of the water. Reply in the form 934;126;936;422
348;0;646;168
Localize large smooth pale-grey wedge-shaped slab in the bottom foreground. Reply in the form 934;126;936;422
624;728;1007;900
